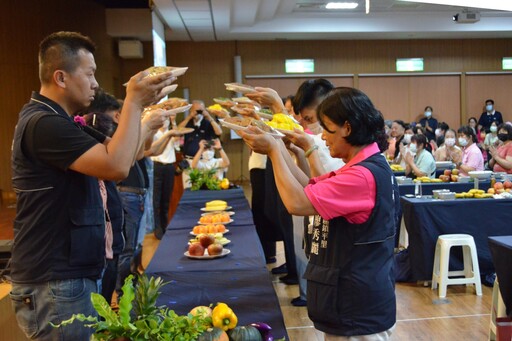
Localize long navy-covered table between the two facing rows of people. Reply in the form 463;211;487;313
146;189;288;338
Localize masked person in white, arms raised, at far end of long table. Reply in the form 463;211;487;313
190;139;229;180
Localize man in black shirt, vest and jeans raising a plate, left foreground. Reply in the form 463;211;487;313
10;32;174;340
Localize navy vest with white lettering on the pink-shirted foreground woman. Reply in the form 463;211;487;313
304;154;399;336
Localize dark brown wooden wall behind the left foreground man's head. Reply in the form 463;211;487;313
0;0;117;192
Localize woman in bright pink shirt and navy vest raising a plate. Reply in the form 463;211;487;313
239;87;400;341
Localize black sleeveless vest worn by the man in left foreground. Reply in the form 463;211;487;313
11;93;105;283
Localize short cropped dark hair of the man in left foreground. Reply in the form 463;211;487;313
39;32;96;84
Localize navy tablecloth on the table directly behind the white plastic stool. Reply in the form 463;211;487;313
401;197;512;281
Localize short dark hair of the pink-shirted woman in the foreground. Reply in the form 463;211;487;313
318;87;384;146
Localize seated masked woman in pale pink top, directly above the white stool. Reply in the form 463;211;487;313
453;126;484;176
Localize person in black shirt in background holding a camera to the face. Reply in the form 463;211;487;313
179;100;222;159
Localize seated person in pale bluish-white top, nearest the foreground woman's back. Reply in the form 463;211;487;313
405;134;436;178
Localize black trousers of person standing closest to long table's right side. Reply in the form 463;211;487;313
250;168;276;260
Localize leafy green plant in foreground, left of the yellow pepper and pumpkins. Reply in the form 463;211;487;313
53;275;211;341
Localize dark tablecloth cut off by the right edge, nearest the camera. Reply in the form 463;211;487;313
489;236;512;316
